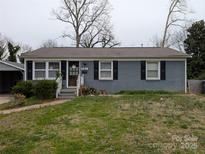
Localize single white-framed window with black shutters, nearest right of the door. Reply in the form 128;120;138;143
99;61;113;80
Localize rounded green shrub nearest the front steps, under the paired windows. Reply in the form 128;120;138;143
35;80;57;99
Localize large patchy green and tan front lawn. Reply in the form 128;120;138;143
0;94;205;154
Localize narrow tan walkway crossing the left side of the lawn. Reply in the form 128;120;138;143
0;100;69;115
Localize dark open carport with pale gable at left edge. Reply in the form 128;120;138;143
0;60;24;94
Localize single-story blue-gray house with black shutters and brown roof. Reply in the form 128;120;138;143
22;47;190;98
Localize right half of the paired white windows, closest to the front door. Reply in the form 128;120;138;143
48;62;59;79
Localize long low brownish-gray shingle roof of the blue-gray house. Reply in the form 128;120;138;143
22;47;189;59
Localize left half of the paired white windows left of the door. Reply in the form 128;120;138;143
35;62;46;80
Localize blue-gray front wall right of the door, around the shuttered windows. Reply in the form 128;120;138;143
83;61;185;93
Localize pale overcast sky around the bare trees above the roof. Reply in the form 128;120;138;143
0;0;205;49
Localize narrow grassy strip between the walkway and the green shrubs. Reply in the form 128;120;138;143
0;97;51;110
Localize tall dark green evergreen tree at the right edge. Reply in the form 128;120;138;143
184;20;205;79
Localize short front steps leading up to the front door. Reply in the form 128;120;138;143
59;88;77;99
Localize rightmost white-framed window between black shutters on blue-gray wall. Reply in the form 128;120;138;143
146;61;160;80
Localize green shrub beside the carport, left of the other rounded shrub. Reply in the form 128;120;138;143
11;81;33;98
